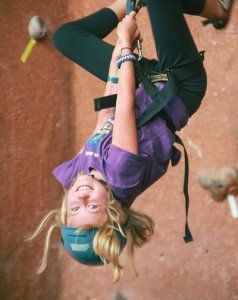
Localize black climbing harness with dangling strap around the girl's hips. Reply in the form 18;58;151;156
94;0;204;243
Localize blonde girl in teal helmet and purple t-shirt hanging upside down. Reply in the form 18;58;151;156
29;0;232;282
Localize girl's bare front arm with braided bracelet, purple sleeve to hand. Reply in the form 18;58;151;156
112;12;140;154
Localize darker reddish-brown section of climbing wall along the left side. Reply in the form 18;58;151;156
0;1;73;300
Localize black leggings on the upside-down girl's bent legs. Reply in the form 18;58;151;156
53;0;207;116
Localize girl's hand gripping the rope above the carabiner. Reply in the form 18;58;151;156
117;11;141;50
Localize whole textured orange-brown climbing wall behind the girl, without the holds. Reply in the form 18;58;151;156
0;0;238;300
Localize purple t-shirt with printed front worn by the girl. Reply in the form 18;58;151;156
53;84;188;206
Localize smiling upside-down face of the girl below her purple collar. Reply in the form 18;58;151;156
67;175;109;227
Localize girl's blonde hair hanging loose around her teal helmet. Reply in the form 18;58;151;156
28;189;154;283
